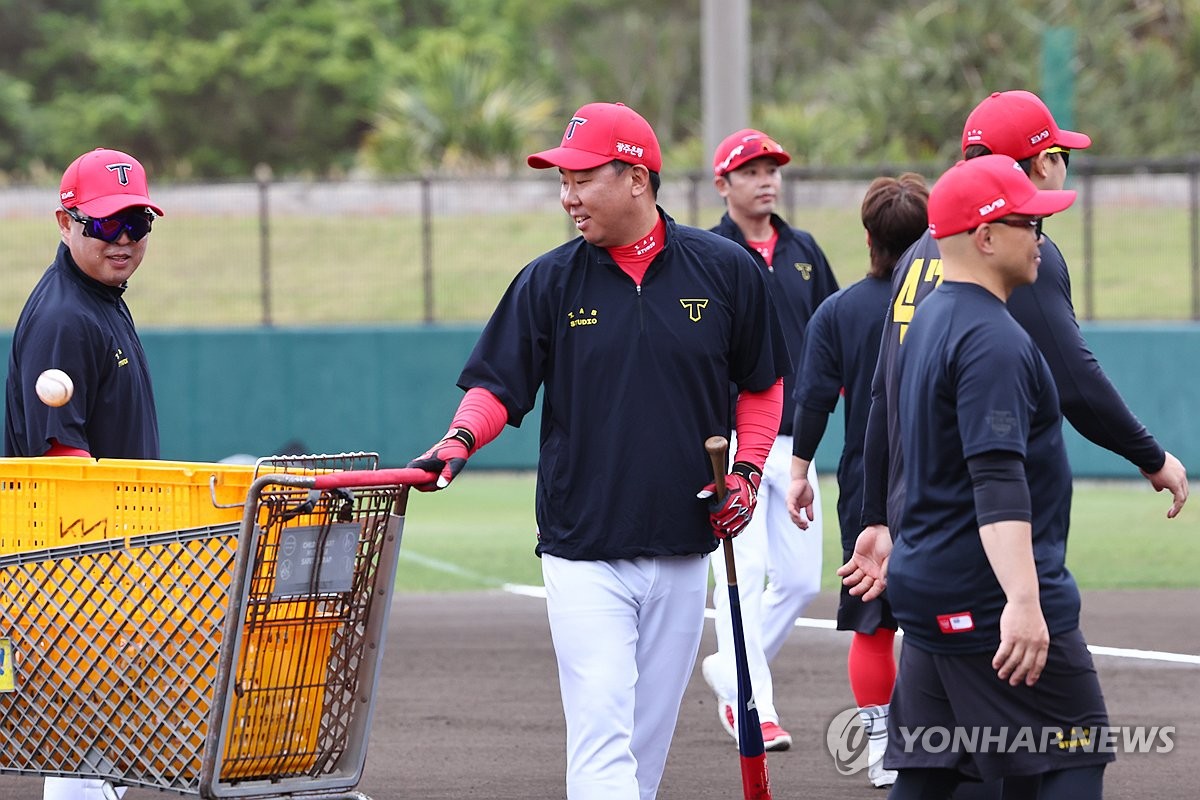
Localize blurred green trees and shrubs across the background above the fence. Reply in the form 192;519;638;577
0;0;1200;178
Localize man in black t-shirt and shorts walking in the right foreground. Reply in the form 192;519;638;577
849;155;1112;800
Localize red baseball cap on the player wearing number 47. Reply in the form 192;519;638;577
962;89;1092;161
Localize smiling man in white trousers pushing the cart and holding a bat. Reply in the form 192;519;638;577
409;103;790;800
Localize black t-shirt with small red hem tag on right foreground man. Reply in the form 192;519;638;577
888;283;1080;652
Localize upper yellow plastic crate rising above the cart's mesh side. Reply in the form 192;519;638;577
0;458;254;554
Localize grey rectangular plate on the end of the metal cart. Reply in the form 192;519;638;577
271;523;362;597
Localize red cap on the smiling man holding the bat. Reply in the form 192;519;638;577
526;103;662;173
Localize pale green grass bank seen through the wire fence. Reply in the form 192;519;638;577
0;198;1192;327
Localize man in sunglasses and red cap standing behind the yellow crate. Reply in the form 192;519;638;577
5;149;162;800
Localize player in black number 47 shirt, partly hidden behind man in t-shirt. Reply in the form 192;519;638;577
862;90;1188;582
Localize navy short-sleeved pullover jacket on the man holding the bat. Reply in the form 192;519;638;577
458;210;788;560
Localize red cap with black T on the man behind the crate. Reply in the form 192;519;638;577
59;148;163;217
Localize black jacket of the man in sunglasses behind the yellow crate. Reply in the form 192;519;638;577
5;245;158;459
